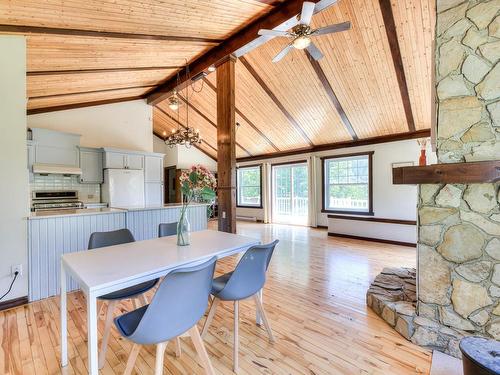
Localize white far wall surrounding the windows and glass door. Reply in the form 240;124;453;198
236;139;436;242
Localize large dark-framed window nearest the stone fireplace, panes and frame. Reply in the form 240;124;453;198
322;152;373;215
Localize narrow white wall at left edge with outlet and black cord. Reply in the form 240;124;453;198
0;36;29;302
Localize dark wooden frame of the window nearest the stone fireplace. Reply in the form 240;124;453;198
321;151;375;216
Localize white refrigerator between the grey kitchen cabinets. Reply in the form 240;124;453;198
101;169;144;208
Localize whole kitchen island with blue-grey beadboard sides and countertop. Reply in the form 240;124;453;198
27;204;208;301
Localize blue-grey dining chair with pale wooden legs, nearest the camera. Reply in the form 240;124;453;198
115;257;217;375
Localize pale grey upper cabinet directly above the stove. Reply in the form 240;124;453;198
31;128;80;167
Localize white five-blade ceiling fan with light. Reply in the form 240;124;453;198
258;1;351;62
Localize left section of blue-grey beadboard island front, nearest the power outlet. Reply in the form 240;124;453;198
28;212;126;301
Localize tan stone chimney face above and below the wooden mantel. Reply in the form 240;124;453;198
412;0;500;356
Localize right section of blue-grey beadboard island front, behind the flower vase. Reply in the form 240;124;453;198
127;206;207;241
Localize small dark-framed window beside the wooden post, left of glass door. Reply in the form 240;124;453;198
236;165;262;208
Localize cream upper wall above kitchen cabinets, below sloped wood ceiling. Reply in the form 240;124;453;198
28;99;153;152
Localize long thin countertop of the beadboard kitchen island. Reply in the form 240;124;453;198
28;203;208;220
